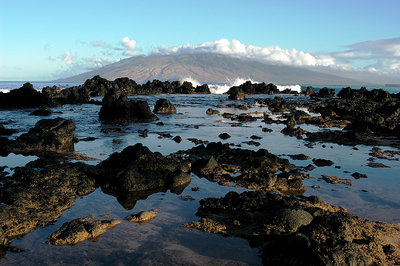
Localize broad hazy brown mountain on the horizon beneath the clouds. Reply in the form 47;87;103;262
57;53;365;85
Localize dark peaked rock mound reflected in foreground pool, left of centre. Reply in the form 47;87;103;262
99;143;190;194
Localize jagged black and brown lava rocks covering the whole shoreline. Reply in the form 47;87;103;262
0;76;400;265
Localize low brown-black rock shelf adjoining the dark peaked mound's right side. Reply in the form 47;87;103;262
183;142;306;194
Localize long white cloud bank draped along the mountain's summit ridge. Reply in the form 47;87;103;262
153;39;335;66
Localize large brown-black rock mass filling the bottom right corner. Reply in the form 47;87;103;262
184;191;400;265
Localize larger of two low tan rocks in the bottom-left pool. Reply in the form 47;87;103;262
46;217;122;246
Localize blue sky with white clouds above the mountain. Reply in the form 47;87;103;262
0;0;400;83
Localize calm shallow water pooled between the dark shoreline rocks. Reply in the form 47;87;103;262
0;95;400;265
